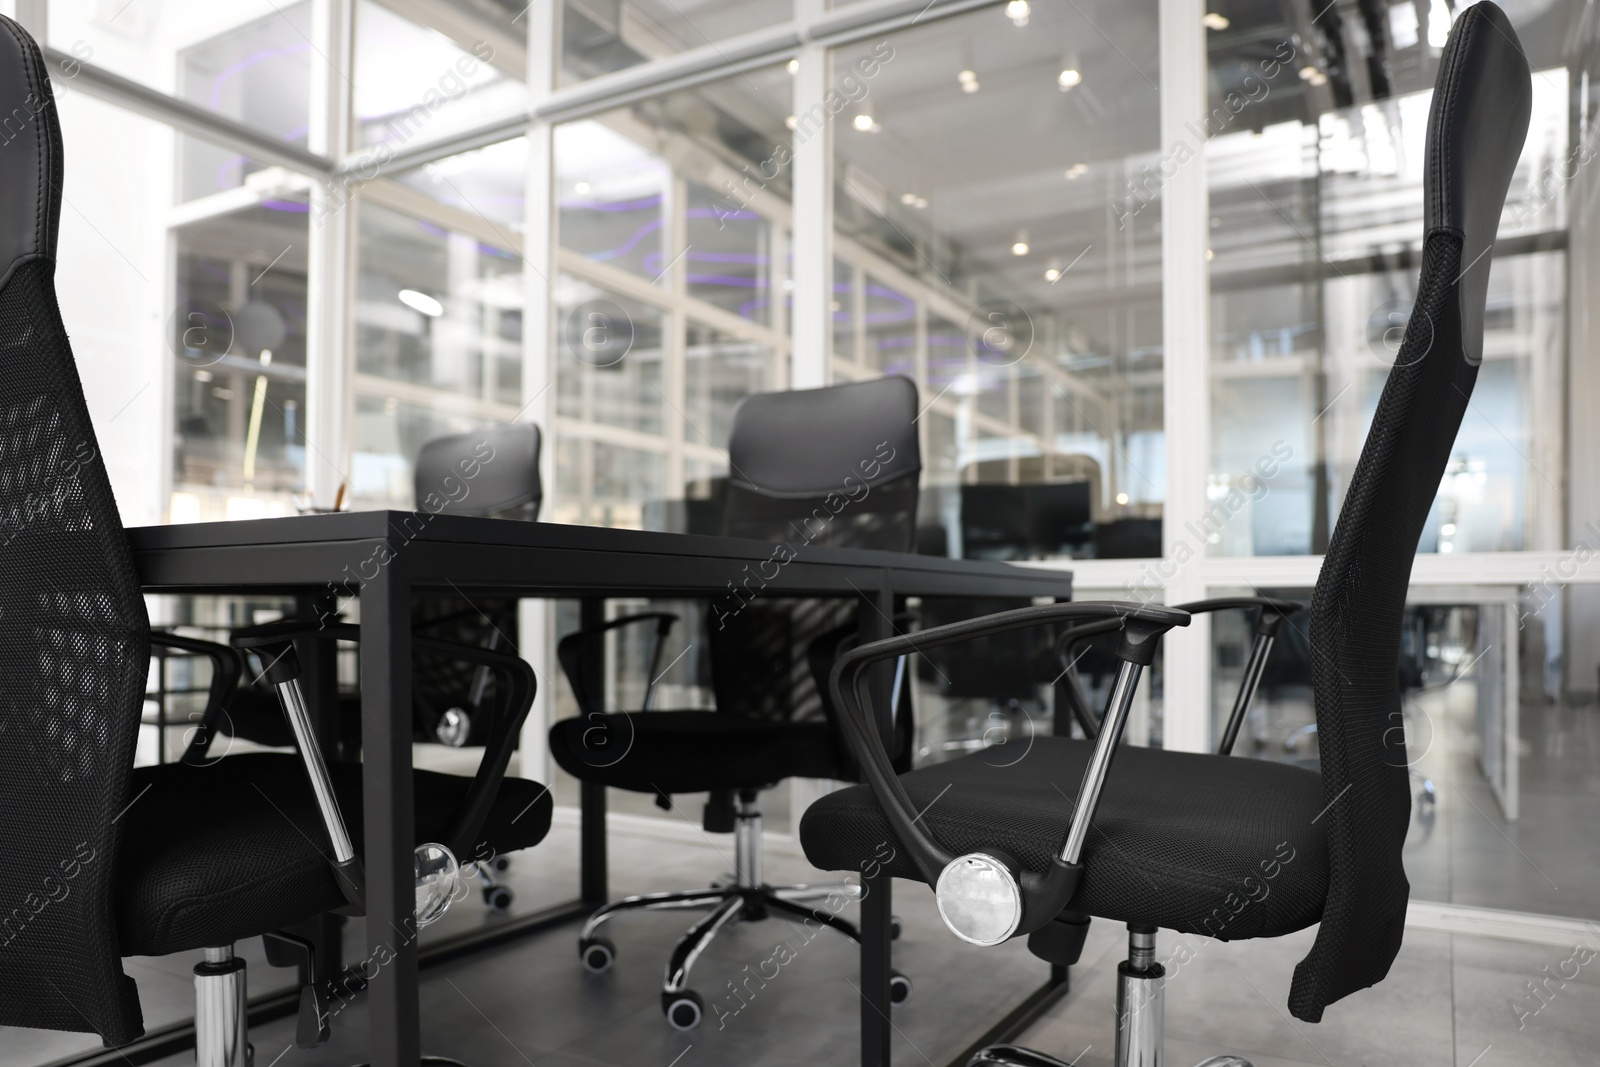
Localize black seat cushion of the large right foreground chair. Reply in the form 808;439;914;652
800;737;1328;941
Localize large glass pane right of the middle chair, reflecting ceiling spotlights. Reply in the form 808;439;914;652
832;0;1165;558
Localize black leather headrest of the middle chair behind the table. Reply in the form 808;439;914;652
728;376;922;498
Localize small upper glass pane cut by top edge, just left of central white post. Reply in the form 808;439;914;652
562;0;794;83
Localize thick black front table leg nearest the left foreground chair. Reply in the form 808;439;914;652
362;559;421;1067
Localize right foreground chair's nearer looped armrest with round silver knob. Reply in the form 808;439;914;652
829;601;1189;944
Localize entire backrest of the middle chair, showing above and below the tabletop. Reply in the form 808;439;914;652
710;378;922;742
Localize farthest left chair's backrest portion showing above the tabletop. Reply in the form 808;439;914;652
413;422;544;520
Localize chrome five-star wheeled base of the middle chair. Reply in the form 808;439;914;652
578;790;912;1030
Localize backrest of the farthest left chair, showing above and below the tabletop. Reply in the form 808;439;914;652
411;422;544;729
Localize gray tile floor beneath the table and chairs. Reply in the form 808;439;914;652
0;809;1600;1067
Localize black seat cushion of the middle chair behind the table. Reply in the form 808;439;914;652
550;712;843;793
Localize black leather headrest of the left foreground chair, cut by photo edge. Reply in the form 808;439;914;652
0;16;61;288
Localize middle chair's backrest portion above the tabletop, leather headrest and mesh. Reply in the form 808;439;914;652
722;378;922;552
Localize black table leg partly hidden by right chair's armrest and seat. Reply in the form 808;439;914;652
856;587;894;1067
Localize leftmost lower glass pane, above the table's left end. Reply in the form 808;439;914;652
166;203;307;508
